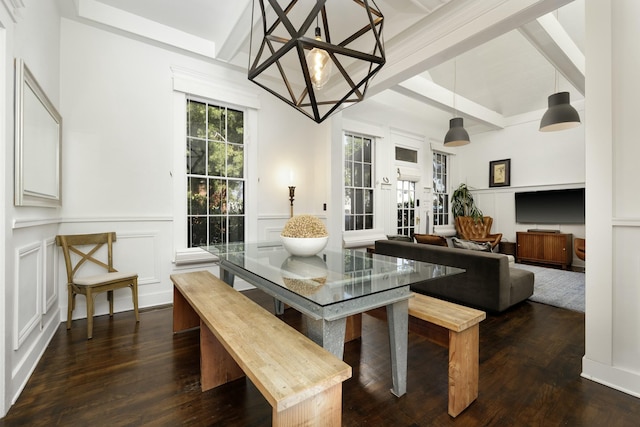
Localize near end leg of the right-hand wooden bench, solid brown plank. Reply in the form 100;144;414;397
449;324;480;417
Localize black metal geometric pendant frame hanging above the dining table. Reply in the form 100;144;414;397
248;0;386;123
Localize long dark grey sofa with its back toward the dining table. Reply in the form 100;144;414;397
375;240;534;312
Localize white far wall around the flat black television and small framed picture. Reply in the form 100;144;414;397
453;108;585;267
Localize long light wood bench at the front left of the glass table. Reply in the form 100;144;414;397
171;271;351;426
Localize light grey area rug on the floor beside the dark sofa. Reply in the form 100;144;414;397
515;264;584;313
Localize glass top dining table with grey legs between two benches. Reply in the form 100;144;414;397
203;242;464;396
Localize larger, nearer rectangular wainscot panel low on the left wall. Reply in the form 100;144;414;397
13;242;42;350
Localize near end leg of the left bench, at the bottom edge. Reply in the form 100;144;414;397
272;383;342;427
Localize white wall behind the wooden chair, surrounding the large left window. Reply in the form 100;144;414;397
59;19;328;317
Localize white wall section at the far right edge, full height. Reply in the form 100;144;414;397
583;0;640;397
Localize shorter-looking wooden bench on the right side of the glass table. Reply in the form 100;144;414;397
409;294;487;417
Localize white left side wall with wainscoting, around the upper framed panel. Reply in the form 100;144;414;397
0;0;60;415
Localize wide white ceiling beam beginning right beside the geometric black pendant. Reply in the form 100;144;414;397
368;0;573;96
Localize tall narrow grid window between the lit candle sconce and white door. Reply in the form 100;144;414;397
344;134;373;231
